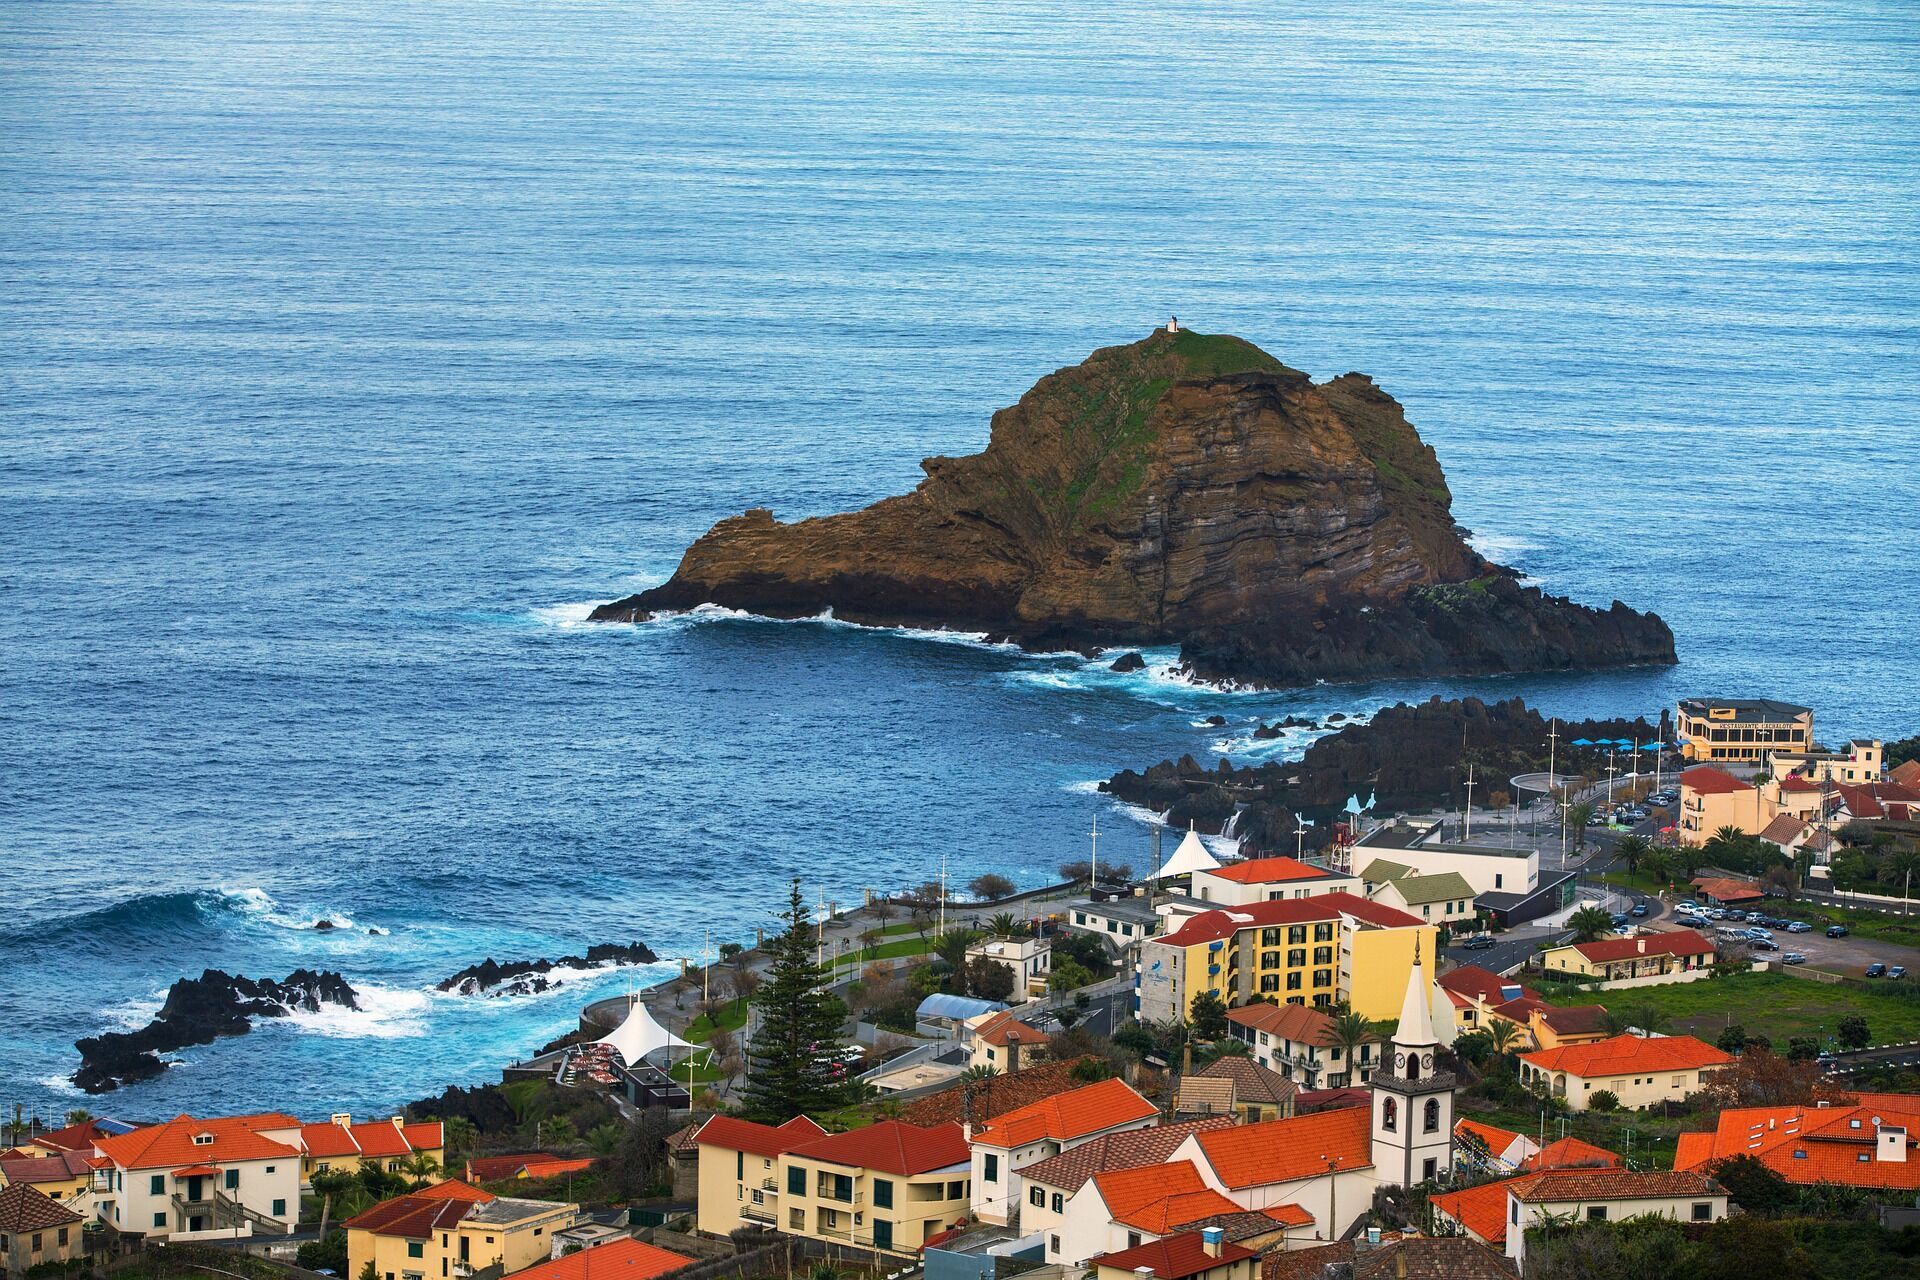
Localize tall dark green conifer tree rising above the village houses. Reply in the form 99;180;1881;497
741;879;858;1125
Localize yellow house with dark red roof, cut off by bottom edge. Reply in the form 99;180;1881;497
346;1180;580;1280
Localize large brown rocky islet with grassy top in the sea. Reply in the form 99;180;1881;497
593;332;1672;683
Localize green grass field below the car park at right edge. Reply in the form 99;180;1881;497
1540;973;1920;1048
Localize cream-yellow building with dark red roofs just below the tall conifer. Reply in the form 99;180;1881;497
695;1117;970;1258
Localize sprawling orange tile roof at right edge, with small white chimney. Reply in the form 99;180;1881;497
1674;1094;1920;1192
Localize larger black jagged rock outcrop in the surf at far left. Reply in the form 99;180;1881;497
73;969;359;1094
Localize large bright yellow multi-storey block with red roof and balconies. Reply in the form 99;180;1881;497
1135;892;1436;1021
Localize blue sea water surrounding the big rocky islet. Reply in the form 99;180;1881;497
0;0;1920;1117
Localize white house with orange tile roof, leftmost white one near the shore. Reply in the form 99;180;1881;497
94;1115;301;1240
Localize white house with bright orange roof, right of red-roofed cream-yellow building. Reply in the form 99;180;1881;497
968;1080;1160;1232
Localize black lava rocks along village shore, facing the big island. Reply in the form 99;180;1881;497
1100;699;1659;854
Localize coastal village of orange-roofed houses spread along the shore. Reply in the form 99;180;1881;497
11;699;1920;1280
